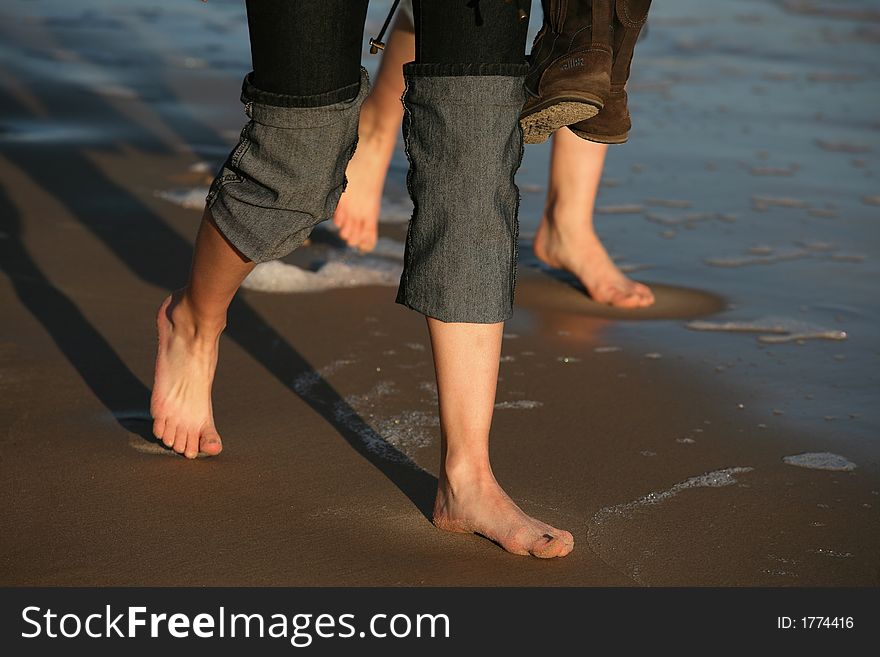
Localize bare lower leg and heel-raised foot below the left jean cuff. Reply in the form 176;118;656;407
150;209;254;458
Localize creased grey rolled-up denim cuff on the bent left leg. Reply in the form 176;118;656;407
206;69;370;263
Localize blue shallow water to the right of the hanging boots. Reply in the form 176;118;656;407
523;0;880;446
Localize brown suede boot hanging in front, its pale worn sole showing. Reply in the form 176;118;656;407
520;0;613;144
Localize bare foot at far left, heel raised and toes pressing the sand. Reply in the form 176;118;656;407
150;292;223;459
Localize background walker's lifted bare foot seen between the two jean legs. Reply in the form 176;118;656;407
333;101;397;252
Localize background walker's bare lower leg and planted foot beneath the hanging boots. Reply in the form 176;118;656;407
534;128;654;308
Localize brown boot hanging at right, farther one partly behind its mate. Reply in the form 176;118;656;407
569;0;651;144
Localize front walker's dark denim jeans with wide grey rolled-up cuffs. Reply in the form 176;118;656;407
207;0;527;323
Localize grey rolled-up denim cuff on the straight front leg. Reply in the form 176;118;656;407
396;70;525;324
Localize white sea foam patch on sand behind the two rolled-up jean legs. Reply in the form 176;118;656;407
242;256;402;293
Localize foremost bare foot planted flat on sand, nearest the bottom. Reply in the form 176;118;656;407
434;466;574;559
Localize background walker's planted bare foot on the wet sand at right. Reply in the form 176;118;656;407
534;205;654;308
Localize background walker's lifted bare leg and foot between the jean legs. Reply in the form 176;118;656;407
333;19;415;251
